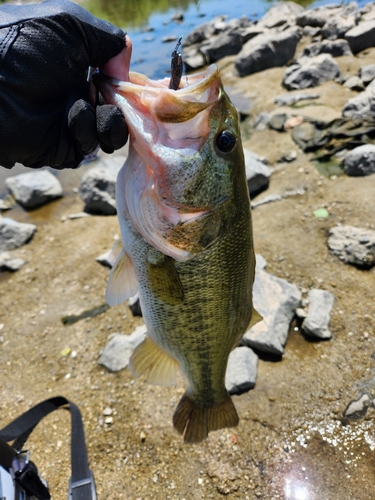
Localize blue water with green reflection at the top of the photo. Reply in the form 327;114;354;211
82;0;372;78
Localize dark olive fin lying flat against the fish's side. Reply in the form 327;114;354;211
147;249;184;306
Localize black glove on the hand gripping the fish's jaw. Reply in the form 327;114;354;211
0;0;128;169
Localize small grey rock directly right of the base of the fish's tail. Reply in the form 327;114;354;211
225;347;258;394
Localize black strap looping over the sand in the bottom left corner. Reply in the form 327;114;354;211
0;396;96;500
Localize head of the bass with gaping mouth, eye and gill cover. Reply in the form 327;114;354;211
97;65;246;261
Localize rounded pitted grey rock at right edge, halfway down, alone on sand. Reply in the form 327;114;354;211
328;226;375;268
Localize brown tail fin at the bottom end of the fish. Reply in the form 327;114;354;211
173;393;239;443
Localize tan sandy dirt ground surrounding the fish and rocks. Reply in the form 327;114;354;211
0;44;375;500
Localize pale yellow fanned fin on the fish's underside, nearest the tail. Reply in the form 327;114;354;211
129;337;178;385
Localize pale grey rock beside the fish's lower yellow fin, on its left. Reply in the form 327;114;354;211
98;325;147;372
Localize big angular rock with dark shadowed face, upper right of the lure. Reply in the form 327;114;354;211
235;28;300;76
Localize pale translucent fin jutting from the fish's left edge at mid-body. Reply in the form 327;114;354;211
105;248;139;306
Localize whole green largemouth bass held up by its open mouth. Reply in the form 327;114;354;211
96;65;261;443
